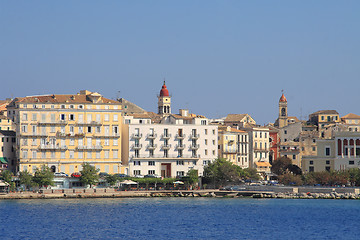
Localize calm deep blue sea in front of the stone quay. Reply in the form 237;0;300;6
0;198;360;239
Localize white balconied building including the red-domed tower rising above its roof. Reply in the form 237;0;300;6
122;83;218;177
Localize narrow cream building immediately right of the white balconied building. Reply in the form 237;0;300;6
218;126;250;168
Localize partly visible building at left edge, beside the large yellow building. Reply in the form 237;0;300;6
0;130;16;172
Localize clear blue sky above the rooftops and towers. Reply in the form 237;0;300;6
0;0;360;124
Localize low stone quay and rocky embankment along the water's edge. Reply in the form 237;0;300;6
0;186;360;199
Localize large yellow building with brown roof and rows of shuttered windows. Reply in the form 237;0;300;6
7;90;124;175
